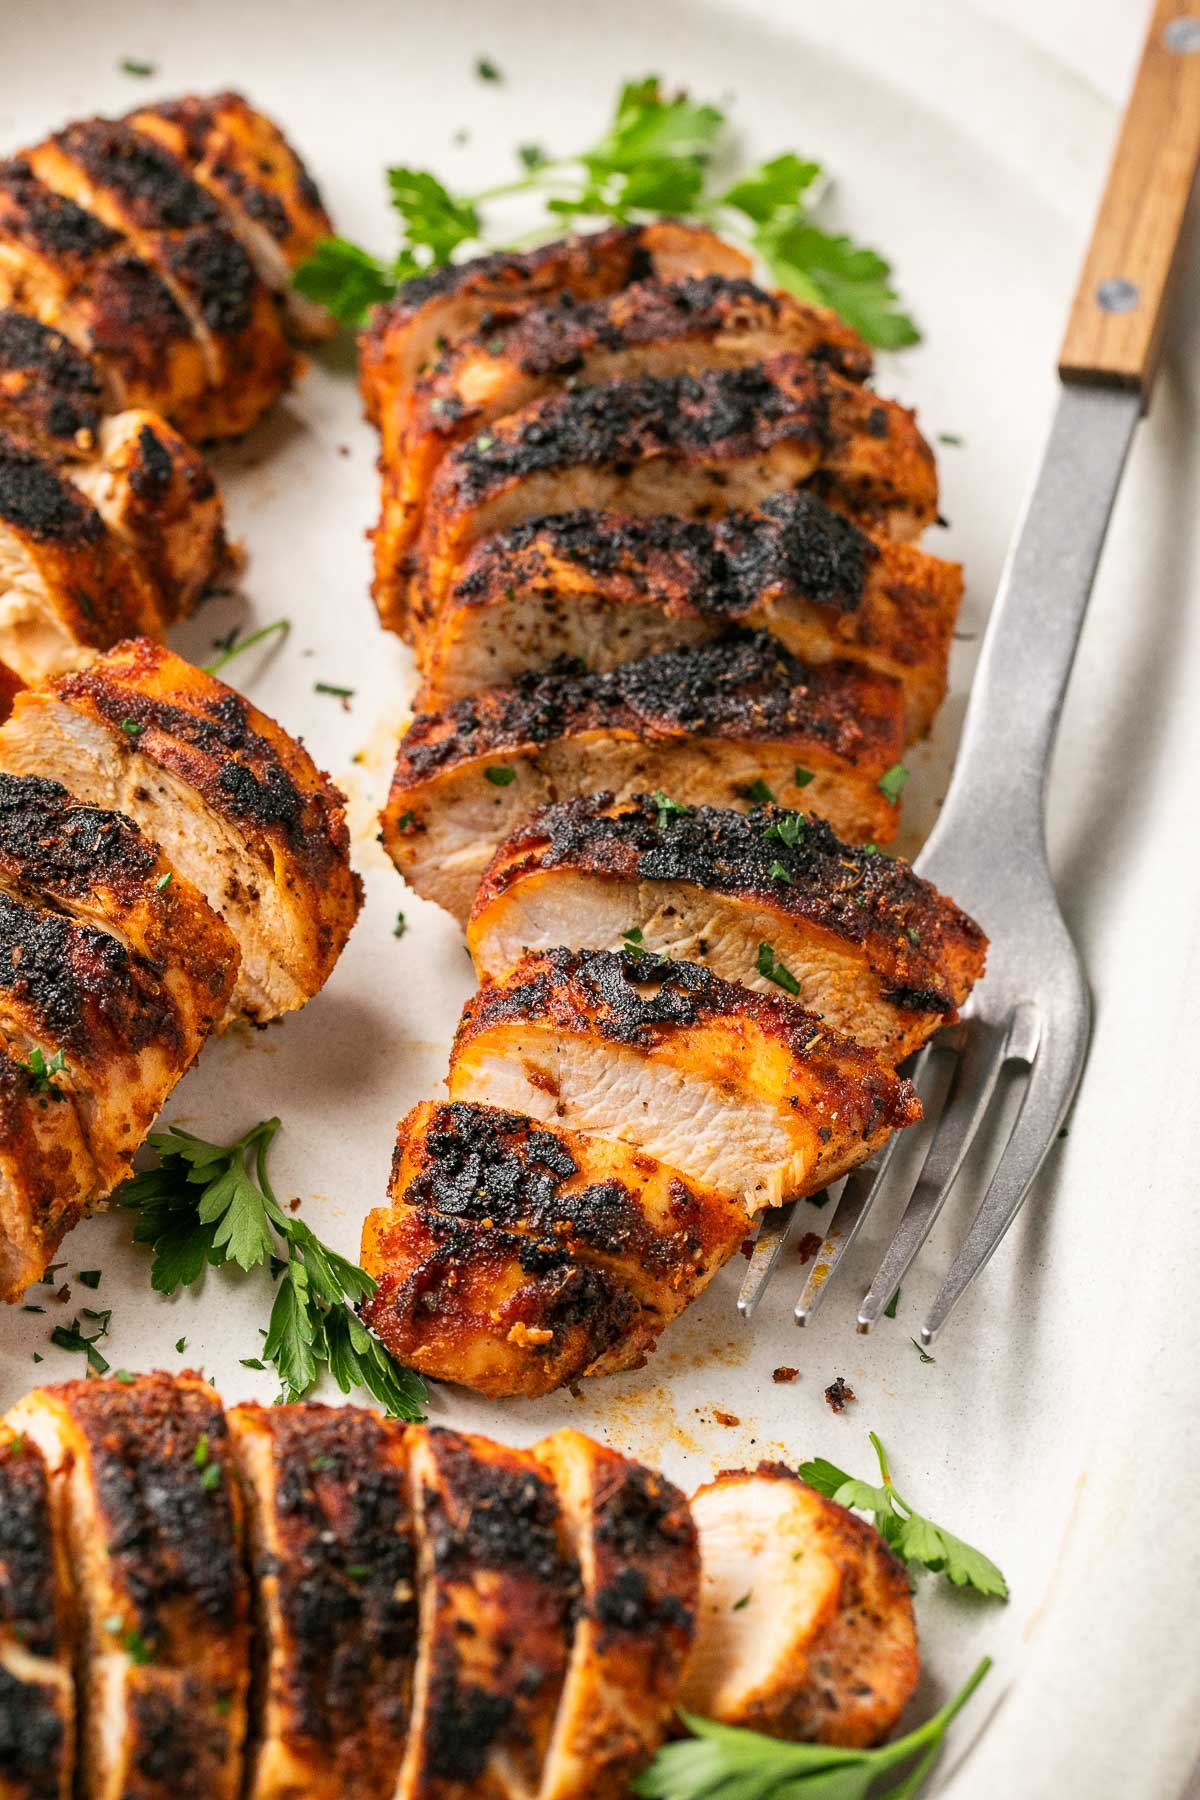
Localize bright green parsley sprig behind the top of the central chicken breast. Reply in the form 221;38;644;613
293;76;919;349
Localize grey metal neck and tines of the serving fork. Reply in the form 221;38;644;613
739;376;1139;1345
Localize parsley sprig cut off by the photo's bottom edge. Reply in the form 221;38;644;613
633;1656;991;1800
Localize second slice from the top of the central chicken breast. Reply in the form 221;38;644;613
374;275;871;623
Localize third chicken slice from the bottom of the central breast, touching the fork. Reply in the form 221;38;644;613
466;794;988;1064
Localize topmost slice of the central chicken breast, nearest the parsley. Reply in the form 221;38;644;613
358;220;750;425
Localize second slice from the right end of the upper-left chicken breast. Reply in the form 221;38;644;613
23;119;295;439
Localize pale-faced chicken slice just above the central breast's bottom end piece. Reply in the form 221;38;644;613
446;950;921;1211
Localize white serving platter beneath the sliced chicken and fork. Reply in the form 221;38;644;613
0;0;1200;1800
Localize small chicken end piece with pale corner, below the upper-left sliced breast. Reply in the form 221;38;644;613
70;410;239;626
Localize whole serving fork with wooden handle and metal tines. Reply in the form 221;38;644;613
738;0;1200;1345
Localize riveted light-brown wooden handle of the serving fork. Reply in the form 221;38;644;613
1058;0;1200;398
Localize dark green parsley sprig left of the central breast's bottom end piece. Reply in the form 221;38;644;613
119;1118;426;1418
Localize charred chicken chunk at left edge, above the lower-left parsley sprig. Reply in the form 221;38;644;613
0;776;237;1300
